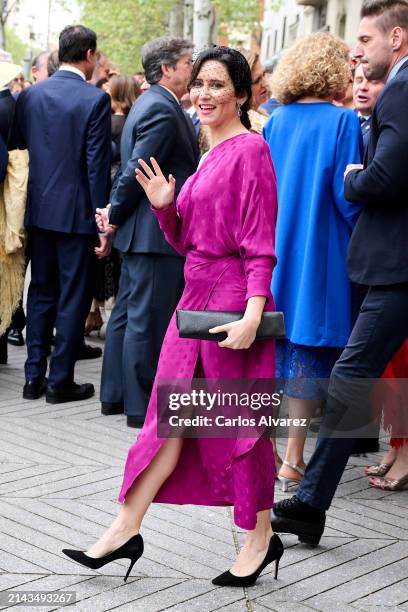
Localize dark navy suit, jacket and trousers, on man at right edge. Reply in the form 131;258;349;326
298;61;408;510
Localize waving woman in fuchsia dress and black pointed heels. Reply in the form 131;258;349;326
65;47;283;586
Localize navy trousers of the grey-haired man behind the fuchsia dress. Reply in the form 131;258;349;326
101;253;184;416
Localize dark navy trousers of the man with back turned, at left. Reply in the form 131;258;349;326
25;227;94;386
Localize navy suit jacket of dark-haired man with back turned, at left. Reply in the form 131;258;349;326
15;70;111;234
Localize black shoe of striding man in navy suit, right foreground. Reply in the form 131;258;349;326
272;495;326;547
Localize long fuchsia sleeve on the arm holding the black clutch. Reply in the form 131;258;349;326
239;141;277;300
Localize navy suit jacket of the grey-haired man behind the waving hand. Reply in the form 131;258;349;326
110;85;199;256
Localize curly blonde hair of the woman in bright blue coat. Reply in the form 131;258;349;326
272;32;351;104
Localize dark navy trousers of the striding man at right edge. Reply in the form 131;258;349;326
297;283;408;510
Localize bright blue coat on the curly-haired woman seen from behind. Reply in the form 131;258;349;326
264;103;362;347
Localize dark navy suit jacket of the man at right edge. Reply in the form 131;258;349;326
345;61;408;285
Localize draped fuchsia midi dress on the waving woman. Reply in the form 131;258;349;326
119;134;277;530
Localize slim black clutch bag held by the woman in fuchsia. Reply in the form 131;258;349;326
176;310;285;342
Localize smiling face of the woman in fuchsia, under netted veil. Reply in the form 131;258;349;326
190;60;246;127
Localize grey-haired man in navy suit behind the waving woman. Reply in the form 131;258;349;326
95;37;198;427
